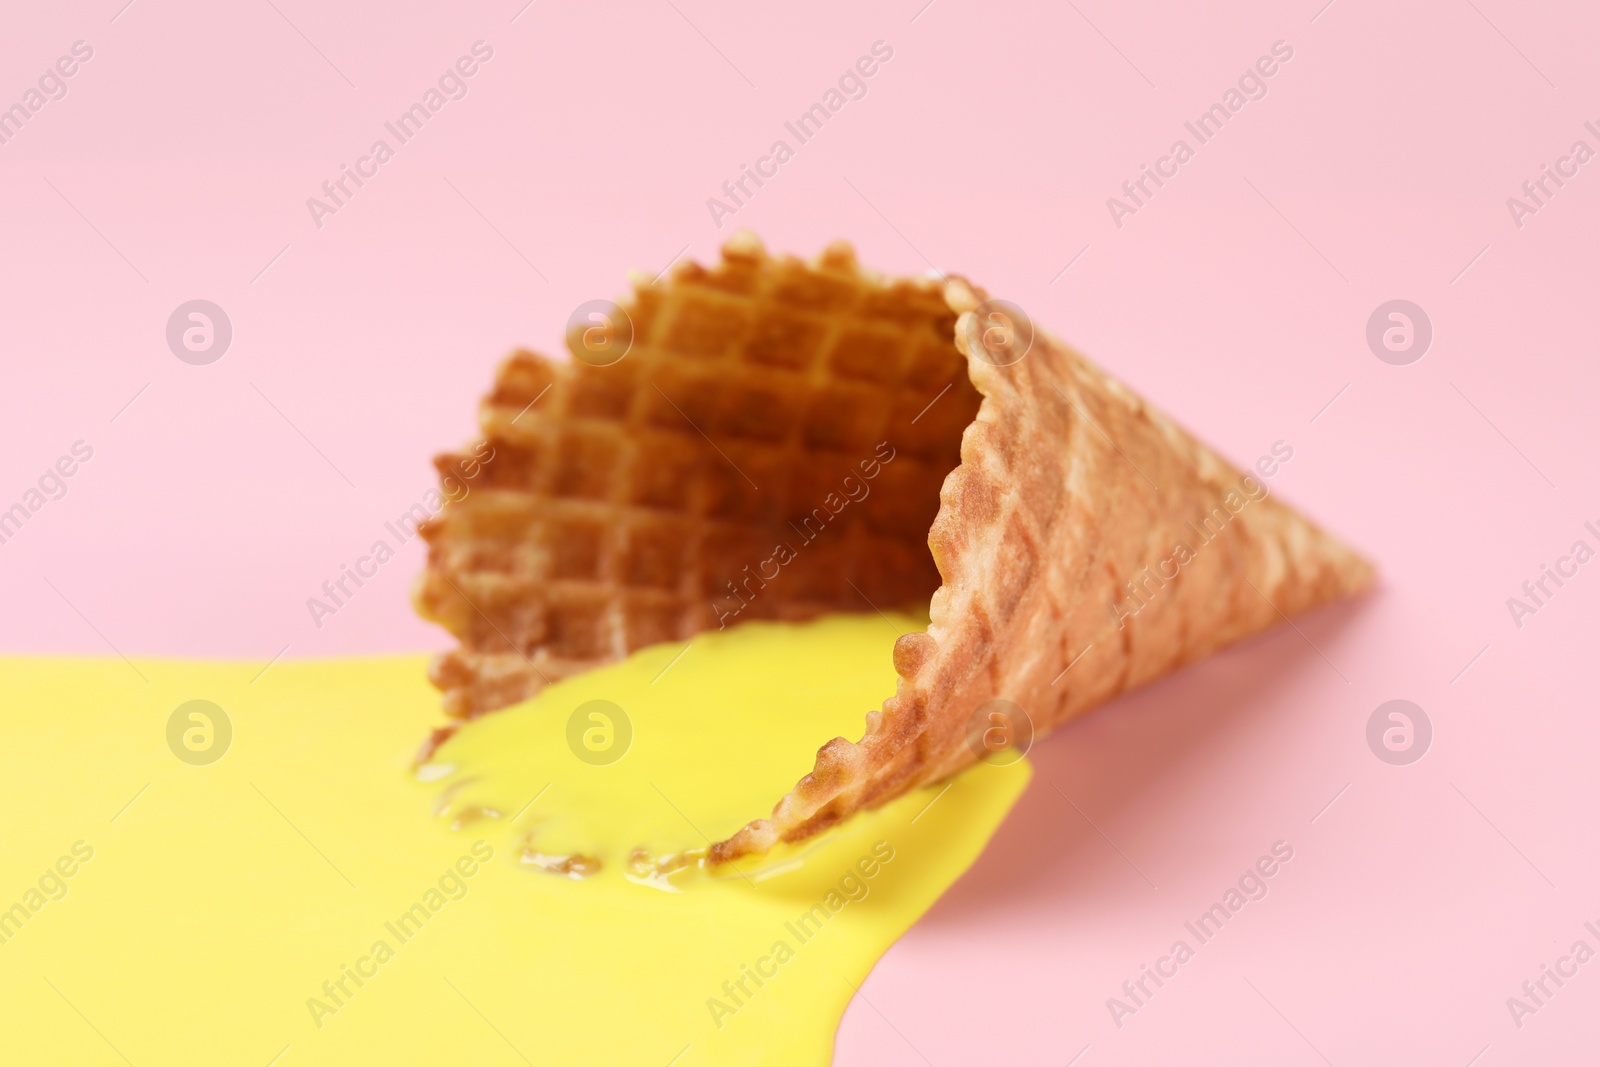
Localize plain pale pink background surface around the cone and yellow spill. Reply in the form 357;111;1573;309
0;0;1600;1067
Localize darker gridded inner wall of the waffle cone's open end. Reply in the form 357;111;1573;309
416;238;981;718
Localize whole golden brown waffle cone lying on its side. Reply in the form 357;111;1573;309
416;234;1371;862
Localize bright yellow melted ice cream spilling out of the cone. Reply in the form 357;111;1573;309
0;616;1027;1067
